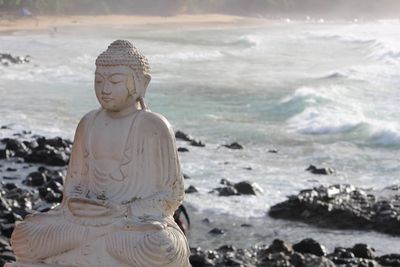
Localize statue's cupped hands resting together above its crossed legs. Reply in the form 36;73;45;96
67;197;124;218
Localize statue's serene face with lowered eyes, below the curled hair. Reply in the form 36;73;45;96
94;66;135;111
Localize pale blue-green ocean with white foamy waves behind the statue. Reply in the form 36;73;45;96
0;20;400;254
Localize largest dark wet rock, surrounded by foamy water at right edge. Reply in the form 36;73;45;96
269;185;400;235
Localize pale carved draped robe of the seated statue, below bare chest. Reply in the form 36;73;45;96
10;109;190;267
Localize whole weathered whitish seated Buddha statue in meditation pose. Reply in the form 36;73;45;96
6;40;190;267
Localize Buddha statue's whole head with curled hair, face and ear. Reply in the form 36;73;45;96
95;40;151;111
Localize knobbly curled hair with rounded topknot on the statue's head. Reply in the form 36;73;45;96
96;40;150;74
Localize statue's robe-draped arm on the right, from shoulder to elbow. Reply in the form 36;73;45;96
126;112;184;220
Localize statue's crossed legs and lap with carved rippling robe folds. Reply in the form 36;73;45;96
10;214;186;267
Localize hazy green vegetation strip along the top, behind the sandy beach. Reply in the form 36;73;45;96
0;0;400;15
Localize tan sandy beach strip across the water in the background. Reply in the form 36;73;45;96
0;14;259;32
